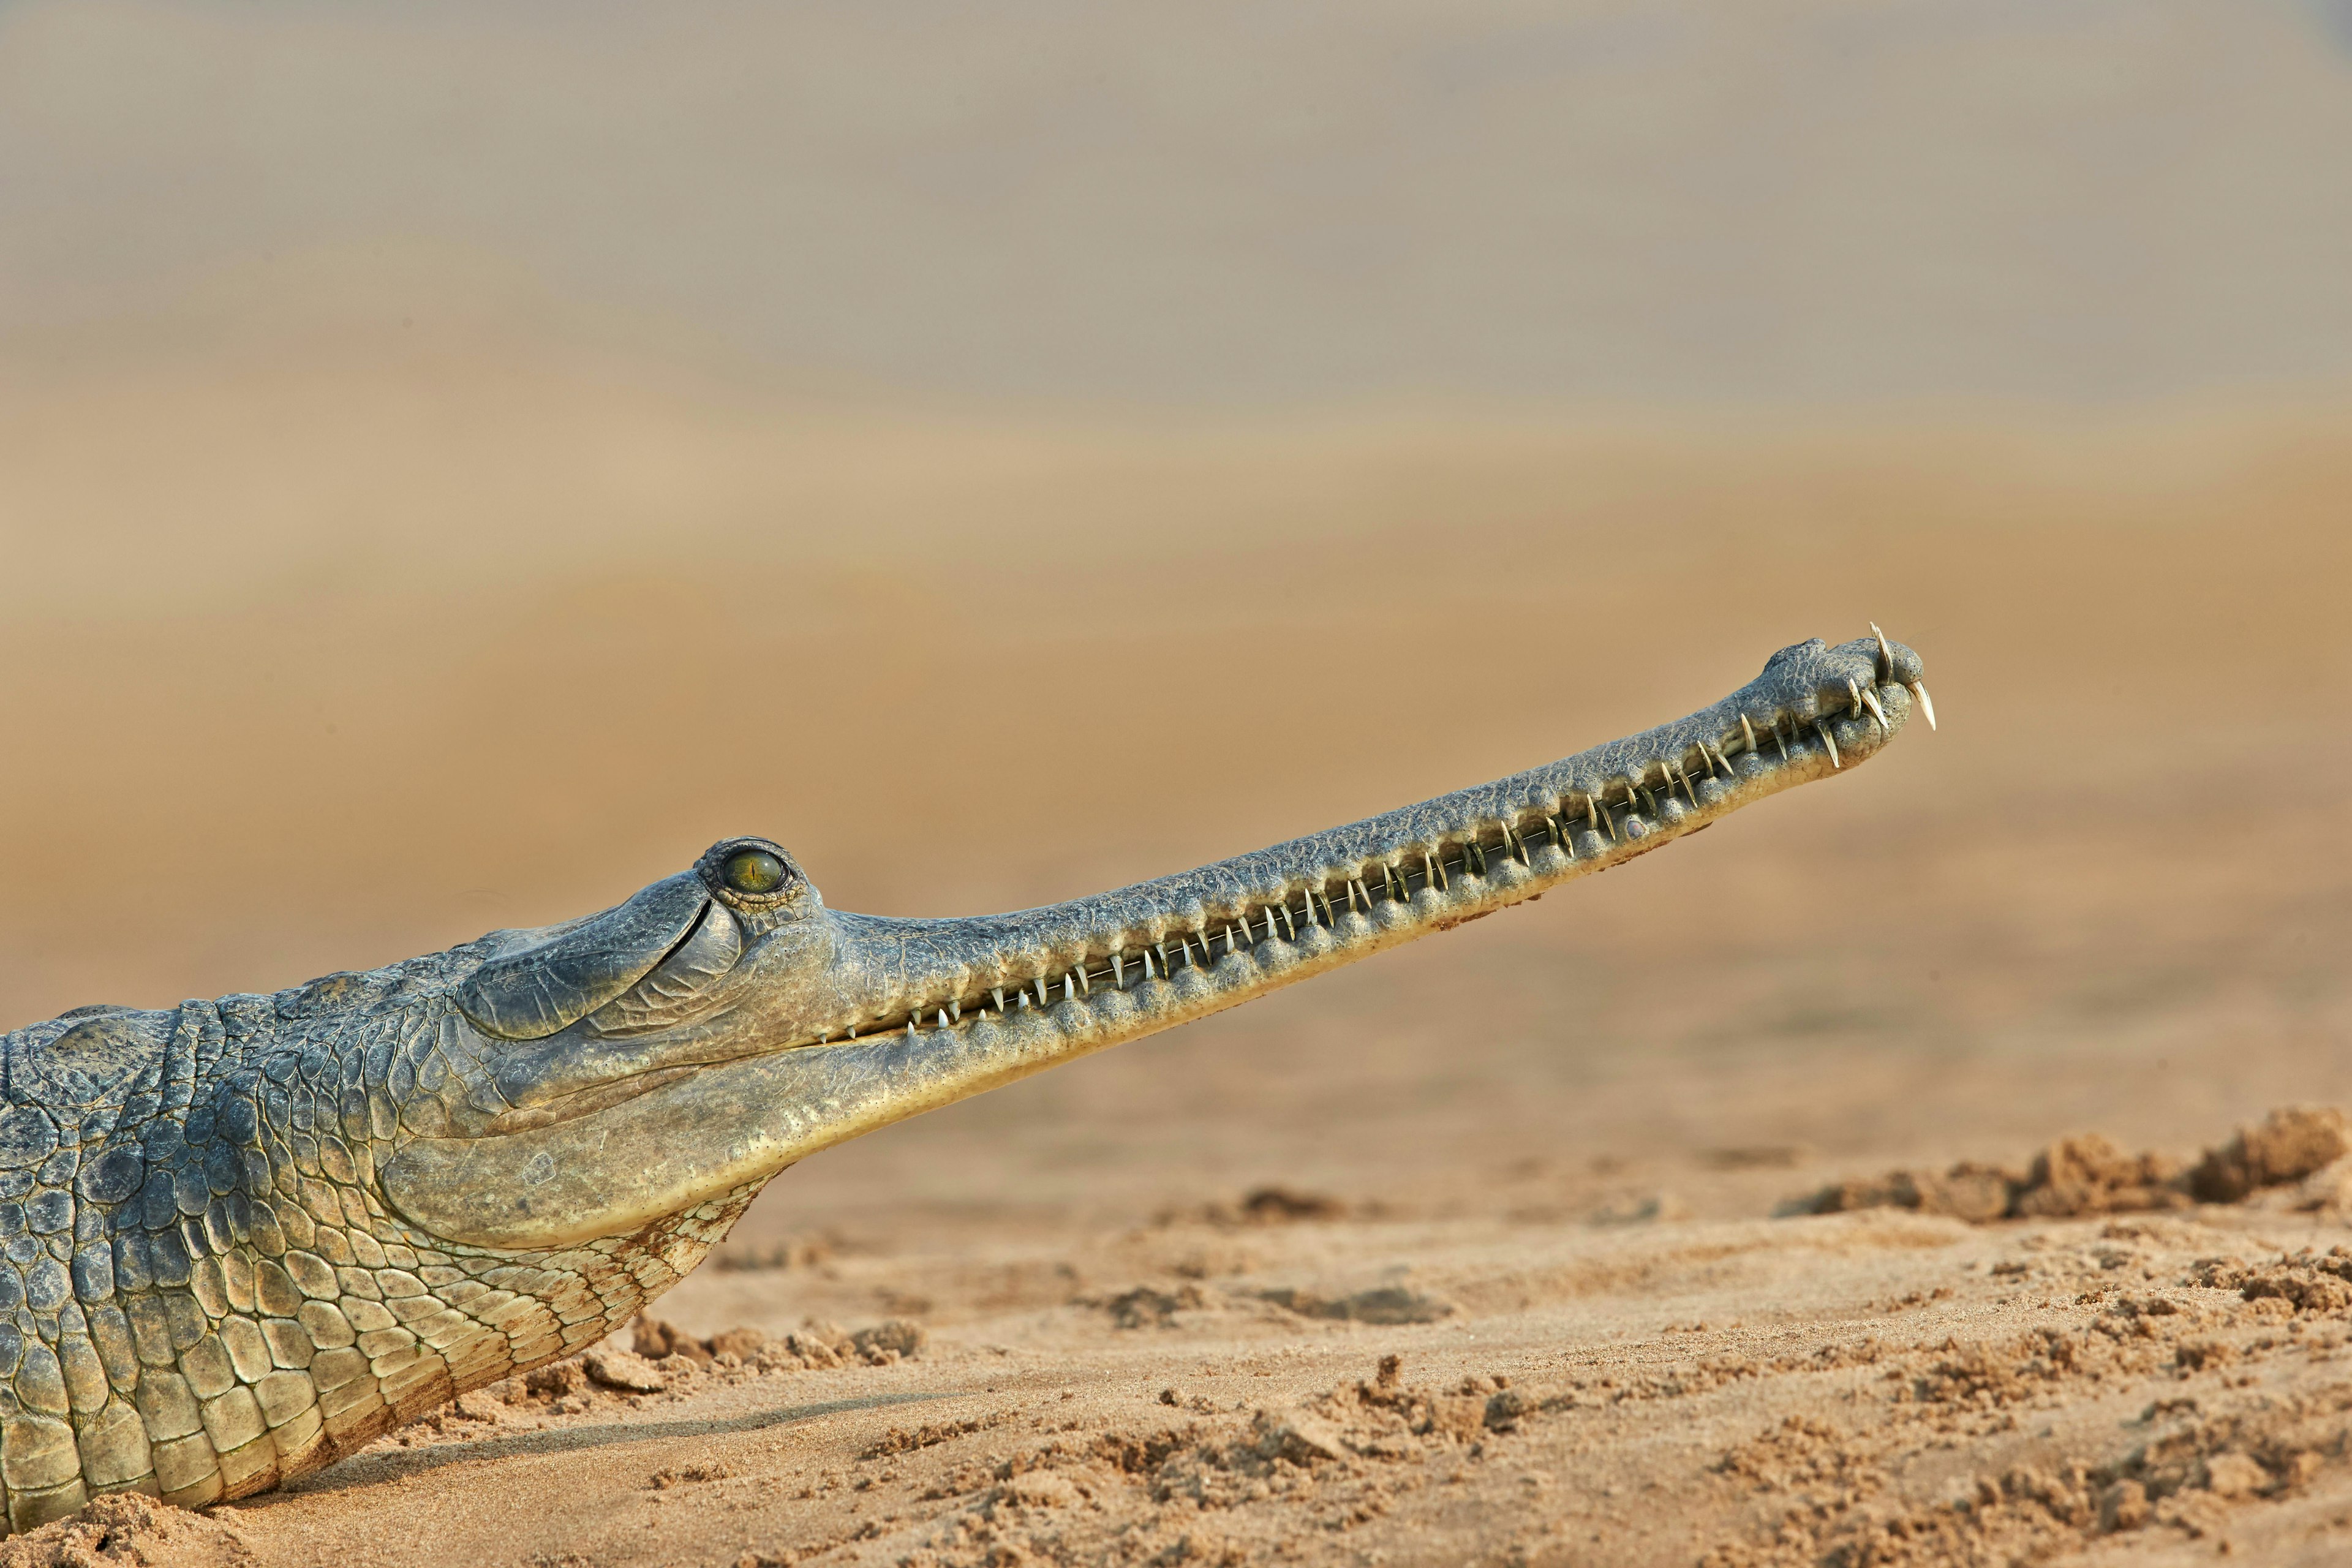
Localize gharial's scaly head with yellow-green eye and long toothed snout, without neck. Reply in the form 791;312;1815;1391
379;628;1933;1248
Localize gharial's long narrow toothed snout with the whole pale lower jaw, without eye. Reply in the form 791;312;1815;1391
383;637;1933;1248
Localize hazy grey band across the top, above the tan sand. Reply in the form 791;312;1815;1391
0;0;2352;407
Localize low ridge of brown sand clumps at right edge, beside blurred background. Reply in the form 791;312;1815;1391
1783;1107;2352;1225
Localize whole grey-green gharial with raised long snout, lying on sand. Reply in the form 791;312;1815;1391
0;628;1933;1531
